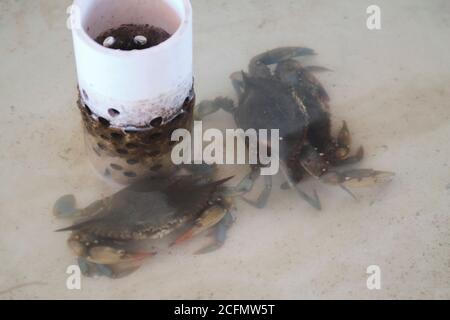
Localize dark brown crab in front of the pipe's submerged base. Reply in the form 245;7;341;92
54;168;233;277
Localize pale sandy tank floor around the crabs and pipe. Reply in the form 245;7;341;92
0;0;450;299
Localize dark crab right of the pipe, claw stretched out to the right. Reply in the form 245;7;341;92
198;47;393;209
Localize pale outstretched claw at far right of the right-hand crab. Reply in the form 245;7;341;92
321;169;395;188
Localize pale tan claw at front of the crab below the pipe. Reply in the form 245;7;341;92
87;246;156;265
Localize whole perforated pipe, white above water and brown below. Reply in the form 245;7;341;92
72;0;195;184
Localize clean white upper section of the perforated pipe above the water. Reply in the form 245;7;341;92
72;0;193;129
